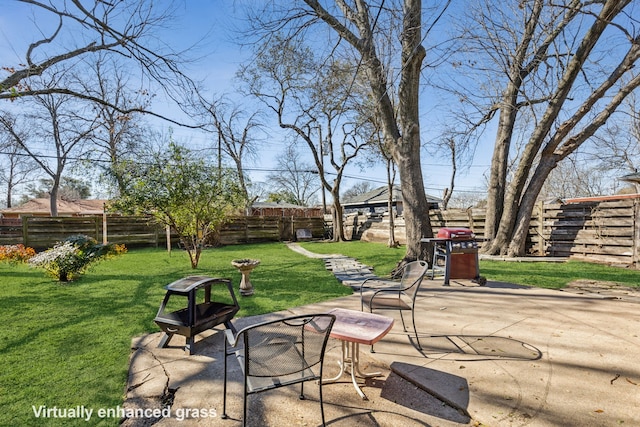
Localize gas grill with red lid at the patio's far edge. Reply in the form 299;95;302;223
421;227;487;286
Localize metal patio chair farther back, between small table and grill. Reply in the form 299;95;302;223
360;260;429;352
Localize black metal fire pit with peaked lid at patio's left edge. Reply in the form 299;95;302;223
154;276;240;354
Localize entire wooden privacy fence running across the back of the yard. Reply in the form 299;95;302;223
0;195;640;267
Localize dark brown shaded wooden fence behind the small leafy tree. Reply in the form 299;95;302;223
0;215;324;250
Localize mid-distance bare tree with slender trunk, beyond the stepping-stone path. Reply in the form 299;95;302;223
240;36;372;241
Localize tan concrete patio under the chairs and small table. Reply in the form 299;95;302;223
123;249;640;427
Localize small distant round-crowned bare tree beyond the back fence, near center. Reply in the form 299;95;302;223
267;146;320;206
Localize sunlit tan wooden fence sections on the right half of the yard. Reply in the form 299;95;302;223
346;195;640;268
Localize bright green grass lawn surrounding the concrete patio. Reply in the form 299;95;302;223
0;242;640;426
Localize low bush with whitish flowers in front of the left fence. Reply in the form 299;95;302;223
29;235;126;282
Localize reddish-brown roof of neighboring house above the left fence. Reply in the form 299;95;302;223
0;198;108;218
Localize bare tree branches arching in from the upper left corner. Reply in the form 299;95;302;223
0;0;198;126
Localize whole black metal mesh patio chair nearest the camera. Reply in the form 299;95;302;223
222;314;335;426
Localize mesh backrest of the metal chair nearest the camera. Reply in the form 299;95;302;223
239;314;335;384
